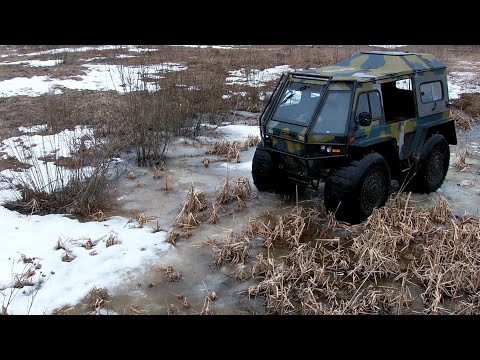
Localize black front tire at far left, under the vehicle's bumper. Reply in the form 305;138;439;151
252;143;306;195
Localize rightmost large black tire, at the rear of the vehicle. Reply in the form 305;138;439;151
409;134;450;194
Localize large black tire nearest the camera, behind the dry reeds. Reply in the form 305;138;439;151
324;153;390;224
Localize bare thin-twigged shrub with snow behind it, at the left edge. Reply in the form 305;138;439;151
4;131;118;217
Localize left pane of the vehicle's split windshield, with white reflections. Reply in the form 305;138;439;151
273;82;324;125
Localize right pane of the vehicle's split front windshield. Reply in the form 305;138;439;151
312;91;352;134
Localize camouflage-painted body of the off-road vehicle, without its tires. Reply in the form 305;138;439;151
252;52;457;222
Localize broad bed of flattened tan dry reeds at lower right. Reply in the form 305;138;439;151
209;194;480;314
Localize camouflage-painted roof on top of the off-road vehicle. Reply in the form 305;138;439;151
298;51;446;82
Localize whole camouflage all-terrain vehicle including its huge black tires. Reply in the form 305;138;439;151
252;51;457;223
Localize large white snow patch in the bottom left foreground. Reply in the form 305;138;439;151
0;206;172;314
